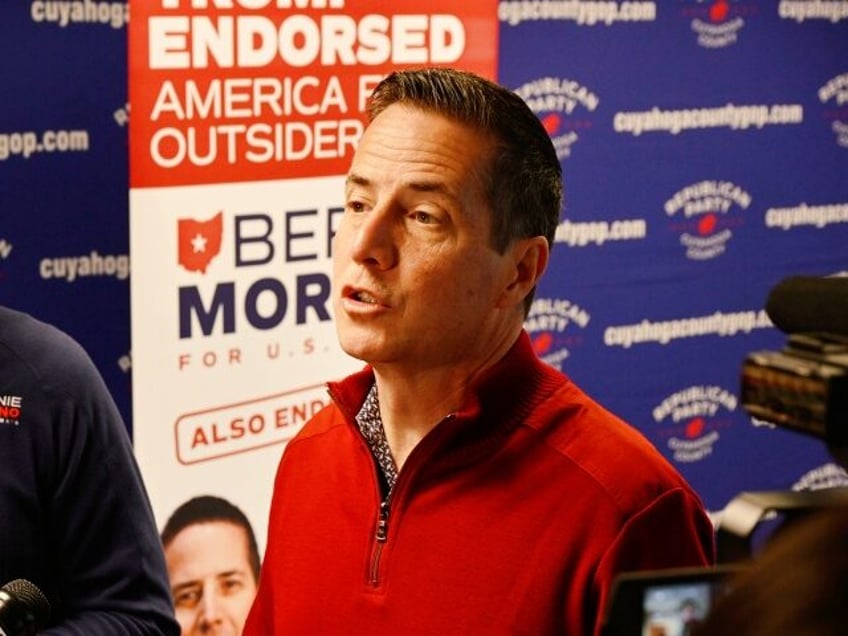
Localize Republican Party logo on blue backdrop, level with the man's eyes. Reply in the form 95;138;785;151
665;180;751;261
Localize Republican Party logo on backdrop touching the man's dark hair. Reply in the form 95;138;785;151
515;77;600;159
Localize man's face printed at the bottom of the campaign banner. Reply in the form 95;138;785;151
165;521;256;636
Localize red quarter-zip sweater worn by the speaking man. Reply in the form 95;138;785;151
244;333;714;636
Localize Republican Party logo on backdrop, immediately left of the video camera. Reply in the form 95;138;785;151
652;385;738;463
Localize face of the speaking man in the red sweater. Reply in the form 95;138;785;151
333;104;520;373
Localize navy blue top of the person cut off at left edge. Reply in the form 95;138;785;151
0;306;180;636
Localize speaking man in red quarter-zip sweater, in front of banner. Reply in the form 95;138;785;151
244;69;714;636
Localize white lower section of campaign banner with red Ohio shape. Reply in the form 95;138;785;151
130;176;361;553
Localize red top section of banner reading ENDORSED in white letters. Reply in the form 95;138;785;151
129;0;498;188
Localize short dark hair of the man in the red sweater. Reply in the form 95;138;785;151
367;68;563;309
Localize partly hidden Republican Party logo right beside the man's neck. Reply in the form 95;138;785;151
524;298;590;371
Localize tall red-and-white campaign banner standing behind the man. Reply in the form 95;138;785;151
129;0;498;547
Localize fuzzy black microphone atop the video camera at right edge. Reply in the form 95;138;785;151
766;276;848;335
